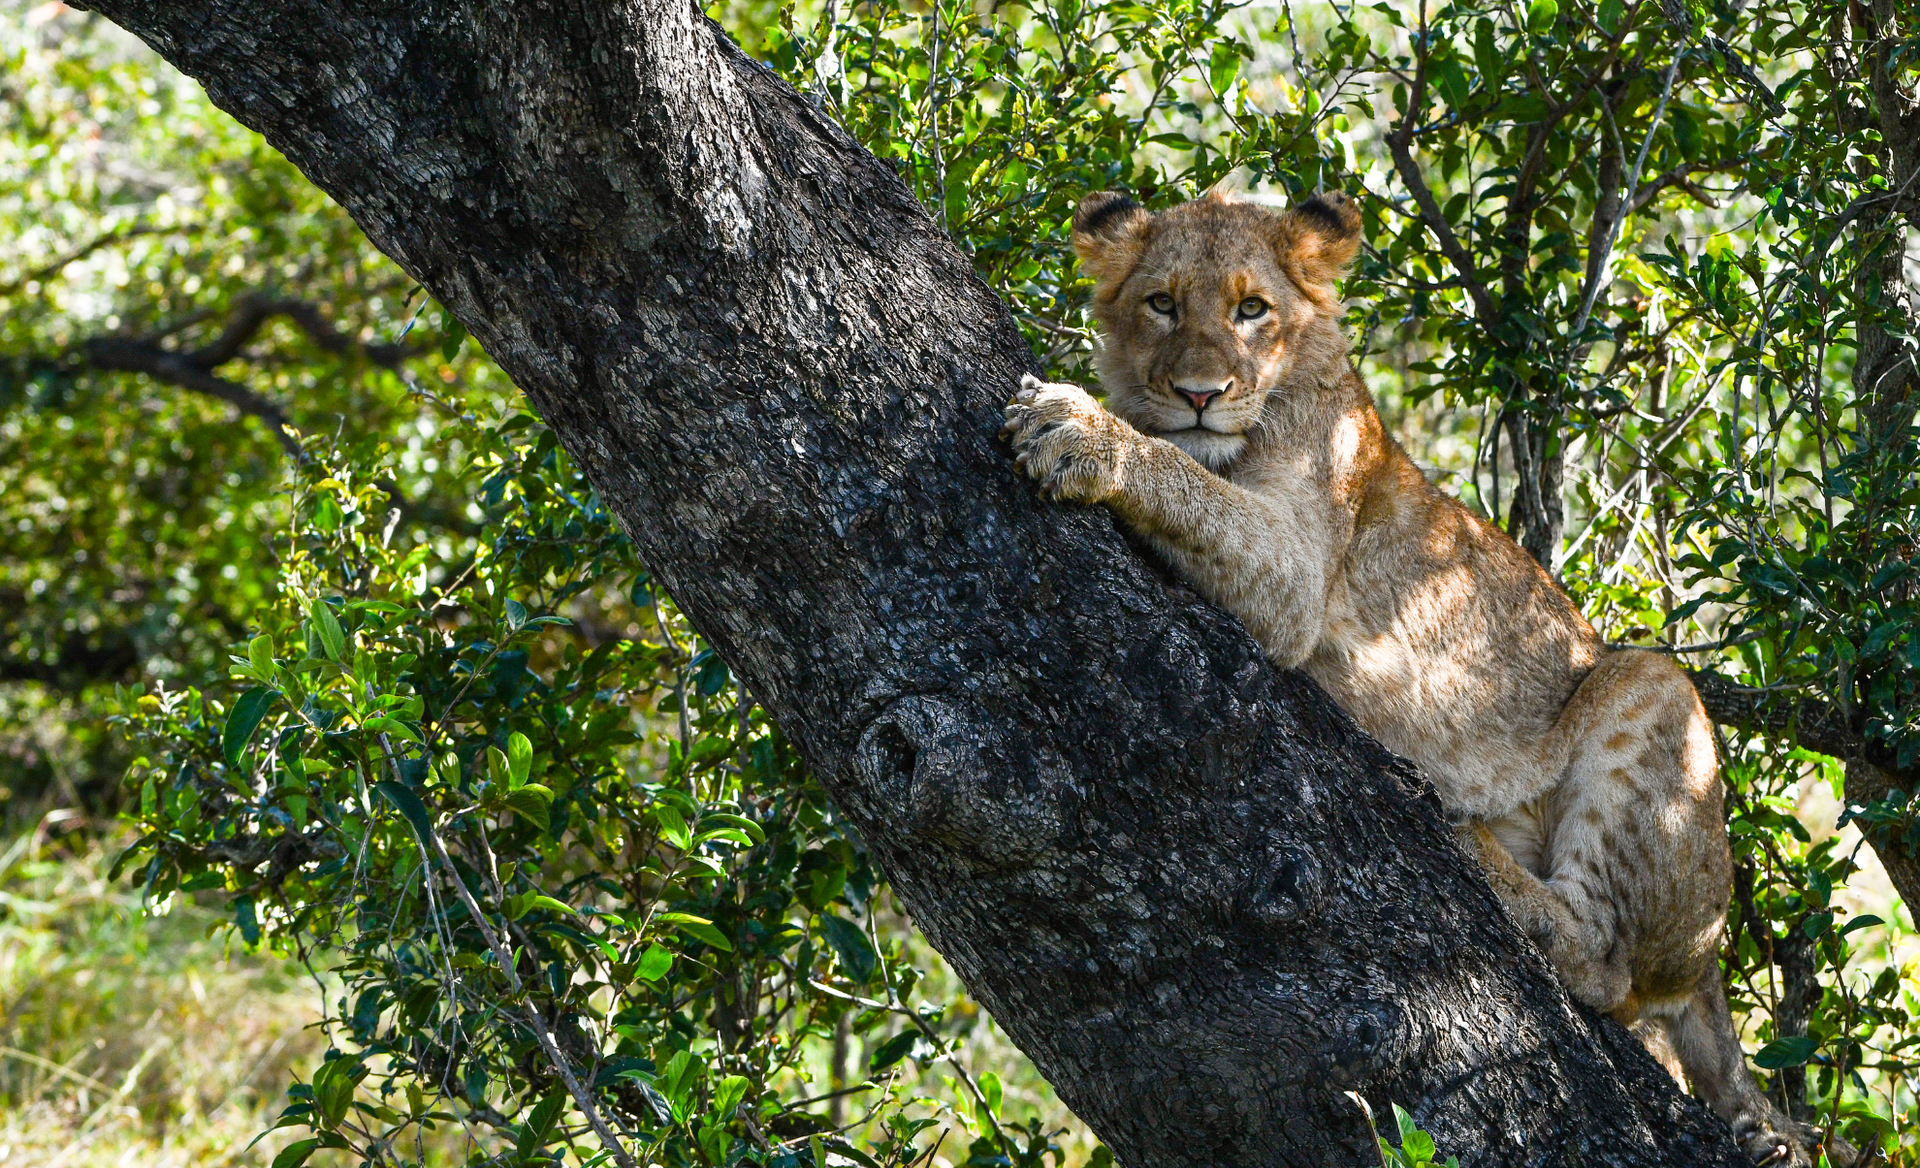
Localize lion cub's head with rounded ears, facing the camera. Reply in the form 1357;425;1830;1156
1073;190;1359;469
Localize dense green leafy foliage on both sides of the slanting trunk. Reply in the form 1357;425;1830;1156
0;0;1920;1166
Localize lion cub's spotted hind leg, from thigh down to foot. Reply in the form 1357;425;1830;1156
1482;649;1851;1168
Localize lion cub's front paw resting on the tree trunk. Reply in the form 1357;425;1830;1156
1000;375;1127;503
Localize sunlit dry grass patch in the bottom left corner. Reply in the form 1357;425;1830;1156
0;820;324;1168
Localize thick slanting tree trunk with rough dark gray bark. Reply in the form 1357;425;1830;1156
74;0;1740;1168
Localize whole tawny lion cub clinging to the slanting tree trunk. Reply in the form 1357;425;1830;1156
1004;192;1816;1164
